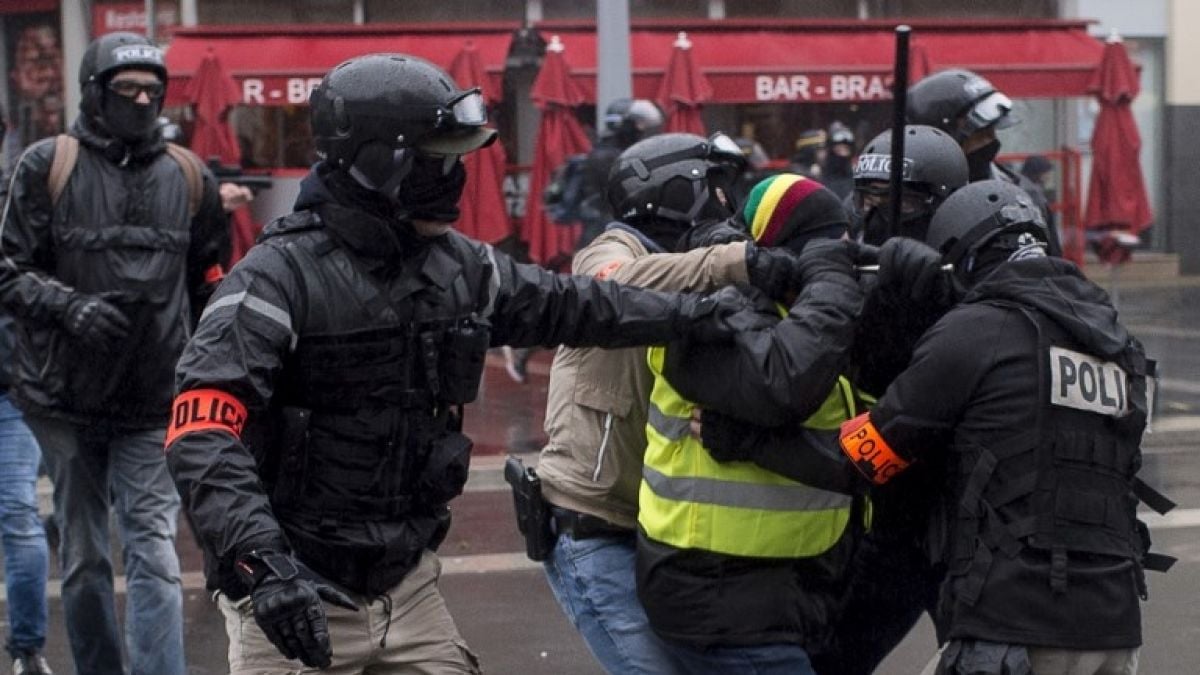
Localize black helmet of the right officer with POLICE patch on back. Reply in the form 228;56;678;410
925;180;1050;287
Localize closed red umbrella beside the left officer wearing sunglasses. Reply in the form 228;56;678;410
184;48;262;265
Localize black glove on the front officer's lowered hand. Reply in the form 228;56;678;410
234;550;358;668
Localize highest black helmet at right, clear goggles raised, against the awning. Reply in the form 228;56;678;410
905;68;1020;144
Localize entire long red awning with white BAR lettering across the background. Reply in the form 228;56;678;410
167;19;1103;106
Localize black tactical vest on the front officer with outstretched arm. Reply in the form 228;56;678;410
251;211;493;593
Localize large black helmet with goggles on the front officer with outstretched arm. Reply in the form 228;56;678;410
308;54;496;169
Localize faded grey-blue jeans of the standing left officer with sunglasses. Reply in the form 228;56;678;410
25;416;187;675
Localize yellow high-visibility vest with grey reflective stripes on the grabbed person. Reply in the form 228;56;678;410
637;347;854;558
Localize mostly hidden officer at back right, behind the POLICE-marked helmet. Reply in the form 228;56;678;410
906;68;1062;255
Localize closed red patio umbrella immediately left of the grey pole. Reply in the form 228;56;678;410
522;35;592;268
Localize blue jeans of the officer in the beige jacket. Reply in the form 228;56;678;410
544;534;686;675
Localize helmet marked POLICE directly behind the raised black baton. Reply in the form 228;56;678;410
854;125;968;244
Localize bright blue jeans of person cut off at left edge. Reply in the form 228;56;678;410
0;394;49;652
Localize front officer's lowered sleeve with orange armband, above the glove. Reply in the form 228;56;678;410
167;241;302;566
